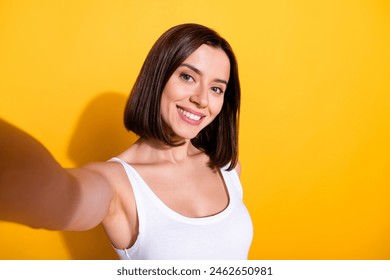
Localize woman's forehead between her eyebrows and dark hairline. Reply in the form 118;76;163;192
183;44;230;80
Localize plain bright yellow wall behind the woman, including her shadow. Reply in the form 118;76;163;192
0;0;390;259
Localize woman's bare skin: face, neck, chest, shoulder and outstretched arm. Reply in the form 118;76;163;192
0;45;240;252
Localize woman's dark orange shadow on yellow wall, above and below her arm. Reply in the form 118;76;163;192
62;93;137;260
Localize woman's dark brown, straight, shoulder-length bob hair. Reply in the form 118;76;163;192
124;23;240;170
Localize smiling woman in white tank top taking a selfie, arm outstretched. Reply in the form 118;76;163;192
0;24;252;259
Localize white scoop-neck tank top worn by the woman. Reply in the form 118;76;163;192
111;158;253;260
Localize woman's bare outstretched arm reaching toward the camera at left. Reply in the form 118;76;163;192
0;120;113;230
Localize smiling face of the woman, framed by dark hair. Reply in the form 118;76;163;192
161;45;230;140
